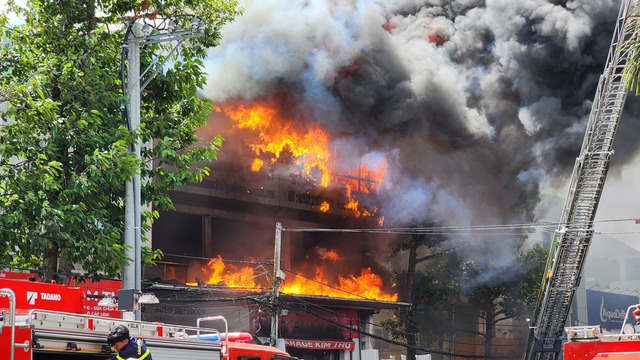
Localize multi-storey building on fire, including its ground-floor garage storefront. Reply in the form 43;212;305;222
145;90;408;359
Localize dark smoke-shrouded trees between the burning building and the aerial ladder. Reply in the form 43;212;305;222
381;236;548;358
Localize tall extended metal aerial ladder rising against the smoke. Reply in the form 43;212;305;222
524;0;640;360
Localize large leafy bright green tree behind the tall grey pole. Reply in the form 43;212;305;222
0;0;241;277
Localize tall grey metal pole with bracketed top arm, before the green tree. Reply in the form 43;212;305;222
121;13;205;320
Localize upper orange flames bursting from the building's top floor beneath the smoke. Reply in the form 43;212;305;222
215;100;387;224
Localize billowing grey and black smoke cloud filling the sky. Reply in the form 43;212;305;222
204;0;640;264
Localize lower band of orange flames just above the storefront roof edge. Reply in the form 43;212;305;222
187;249;398;301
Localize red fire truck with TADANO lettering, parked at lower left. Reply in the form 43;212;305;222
0;279;295;360
